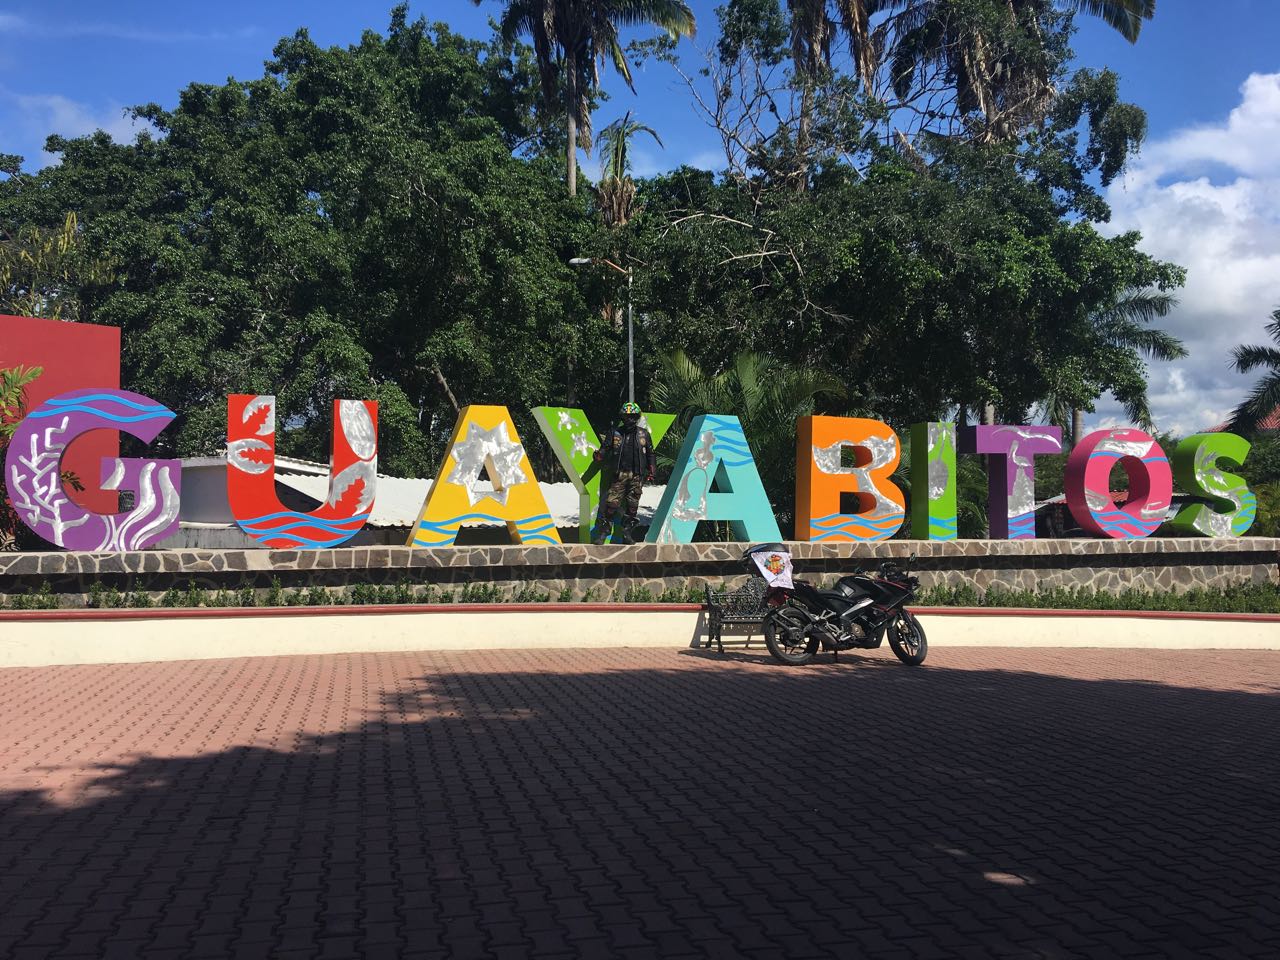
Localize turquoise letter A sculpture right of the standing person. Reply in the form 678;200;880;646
645;413;782;543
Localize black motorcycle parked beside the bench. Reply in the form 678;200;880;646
742;544;929;667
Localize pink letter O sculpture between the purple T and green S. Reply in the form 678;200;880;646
1064;429;1174;540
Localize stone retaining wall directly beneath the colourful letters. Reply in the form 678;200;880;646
0;538;1280;607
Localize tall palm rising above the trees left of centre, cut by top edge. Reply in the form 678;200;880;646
488;0;696;197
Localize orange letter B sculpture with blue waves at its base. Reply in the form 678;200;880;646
796;416;906;543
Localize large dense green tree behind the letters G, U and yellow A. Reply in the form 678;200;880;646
0;10;622;476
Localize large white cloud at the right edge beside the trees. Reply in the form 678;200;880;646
1091;73;1280;434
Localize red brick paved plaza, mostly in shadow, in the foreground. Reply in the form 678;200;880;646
0;649;1280;960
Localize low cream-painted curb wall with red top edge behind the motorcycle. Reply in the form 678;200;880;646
0;603;1280;667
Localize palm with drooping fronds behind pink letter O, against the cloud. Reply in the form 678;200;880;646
1041;288;1187;447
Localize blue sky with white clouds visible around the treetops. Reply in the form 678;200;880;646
0;0;1280;430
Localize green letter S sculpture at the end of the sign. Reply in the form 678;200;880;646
1169;434;1258;536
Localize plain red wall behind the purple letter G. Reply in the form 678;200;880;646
0;315;120;513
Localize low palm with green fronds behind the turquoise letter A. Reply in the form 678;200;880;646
649;349;845;518
